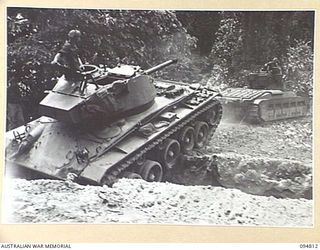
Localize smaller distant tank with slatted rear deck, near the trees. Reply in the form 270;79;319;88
219;69;310;123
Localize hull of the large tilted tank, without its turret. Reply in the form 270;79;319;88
6;81;222;185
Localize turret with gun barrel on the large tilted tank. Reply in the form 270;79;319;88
40;60;177;124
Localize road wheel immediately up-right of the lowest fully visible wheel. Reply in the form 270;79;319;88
159;138;180;169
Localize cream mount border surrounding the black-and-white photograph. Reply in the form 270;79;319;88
0;0;320;243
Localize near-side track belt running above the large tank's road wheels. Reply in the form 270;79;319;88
100;98;222;186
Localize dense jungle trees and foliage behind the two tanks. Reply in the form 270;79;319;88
7;7;314;124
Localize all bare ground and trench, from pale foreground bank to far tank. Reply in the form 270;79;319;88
4;116;313;227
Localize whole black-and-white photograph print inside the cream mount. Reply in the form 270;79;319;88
2;7;315;228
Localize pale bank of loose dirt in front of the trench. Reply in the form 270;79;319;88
3;179;312;227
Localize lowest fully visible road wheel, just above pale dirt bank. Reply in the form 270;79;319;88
140;160;163;182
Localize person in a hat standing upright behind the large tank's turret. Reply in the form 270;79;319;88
51;30;84;78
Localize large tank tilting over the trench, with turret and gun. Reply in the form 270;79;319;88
6;60;222;186
